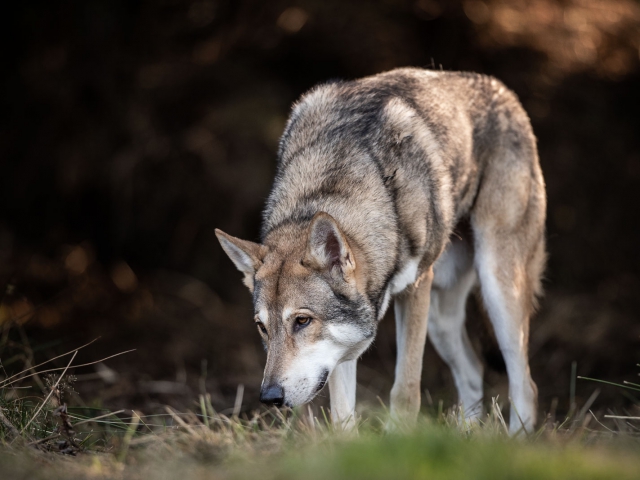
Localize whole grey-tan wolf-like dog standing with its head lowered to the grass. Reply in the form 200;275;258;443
216;68;546;433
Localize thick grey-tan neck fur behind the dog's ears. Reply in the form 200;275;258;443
263;139;399;300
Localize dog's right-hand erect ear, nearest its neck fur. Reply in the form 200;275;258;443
305;212;356;282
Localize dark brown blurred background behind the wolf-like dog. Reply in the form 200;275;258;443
0;0;640;418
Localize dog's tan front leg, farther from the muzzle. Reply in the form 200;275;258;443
391;268;433;423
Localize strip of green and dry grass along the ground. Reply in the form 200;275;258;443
0;332;640;480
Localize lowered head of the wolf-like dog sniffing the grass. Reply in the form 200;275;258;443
216;212;377;407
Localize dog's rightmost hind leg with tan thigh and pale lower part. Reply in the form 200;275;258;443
471;142;546;434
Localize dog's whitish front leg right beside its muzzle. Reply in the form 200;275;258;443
329;360;357;430
